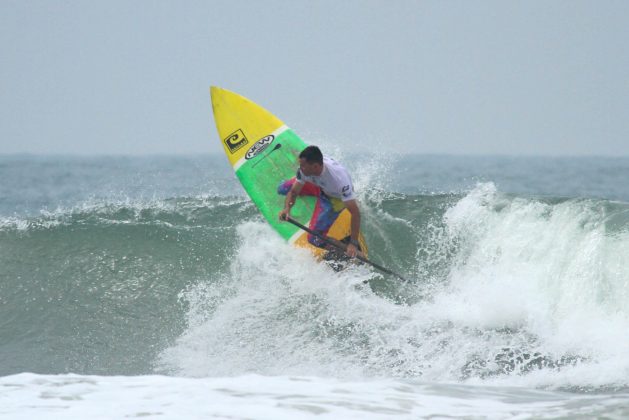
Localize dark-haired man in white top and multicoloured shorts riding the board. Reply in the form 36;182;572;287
277;146;360;258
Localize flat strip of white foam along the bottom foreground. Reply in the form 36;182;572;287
0;374;629;420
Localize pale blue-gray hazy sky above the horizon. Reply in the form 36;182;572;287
0;0;629;156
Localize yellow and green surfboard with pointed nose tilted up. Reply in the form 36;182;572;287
210;86;367;256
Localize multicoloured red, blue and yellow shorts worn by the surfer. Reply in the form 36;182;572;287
277;178;345;248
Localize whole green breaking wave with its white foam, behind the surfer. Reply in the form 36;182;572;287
0;183;629;389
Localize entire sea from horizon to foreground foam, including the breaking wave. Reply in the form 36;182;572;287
0;154;629;419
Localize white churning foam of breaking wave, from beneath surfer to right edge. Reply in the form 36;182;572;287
158;184;629;388
